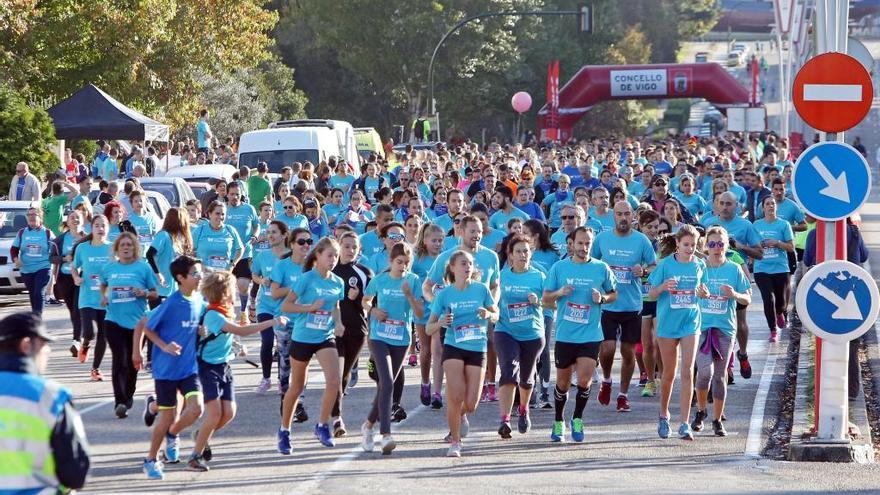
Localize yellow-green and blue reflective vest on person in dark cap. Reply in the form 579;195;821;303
0;371;70;493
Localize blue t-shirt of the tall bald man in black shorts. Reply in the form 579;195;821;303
590;230;657;311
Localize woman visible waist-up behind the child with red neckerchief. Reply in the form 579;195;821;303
193;201;244;272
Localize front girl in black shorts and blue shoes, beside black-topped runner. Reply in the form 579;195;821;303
278;237;346;455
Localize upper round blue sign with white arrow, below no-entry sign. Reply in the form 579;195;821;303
791;141;871;221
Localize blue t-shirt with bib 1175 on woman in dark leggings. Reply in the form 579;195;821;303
364;272;422;347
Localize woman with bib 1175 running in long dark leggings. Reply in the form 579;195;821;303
361;241;424;455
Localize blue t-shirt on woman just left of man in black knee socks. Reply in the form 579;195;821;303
495;267;547;342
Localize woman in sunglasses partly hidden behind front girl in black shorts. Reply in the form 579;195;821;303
269;229;314;423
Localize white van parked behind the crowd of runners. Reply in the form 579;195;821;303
238;119;360;175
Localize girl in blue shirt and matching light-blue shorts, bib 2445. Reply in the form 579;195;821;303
648;225;709;440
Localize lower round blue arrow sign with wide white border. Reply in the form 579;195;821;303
795;260;880;342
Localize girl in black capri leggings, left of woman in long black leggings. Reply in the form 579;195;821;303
70;215;113;382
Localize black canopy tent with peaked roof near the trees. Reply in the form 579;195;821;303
48;83;168;142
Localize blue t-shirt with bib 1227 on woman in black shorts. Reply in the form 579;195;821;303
431;282;495;352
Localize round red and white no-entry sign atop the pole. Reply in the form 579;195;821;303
792;53;874;132
